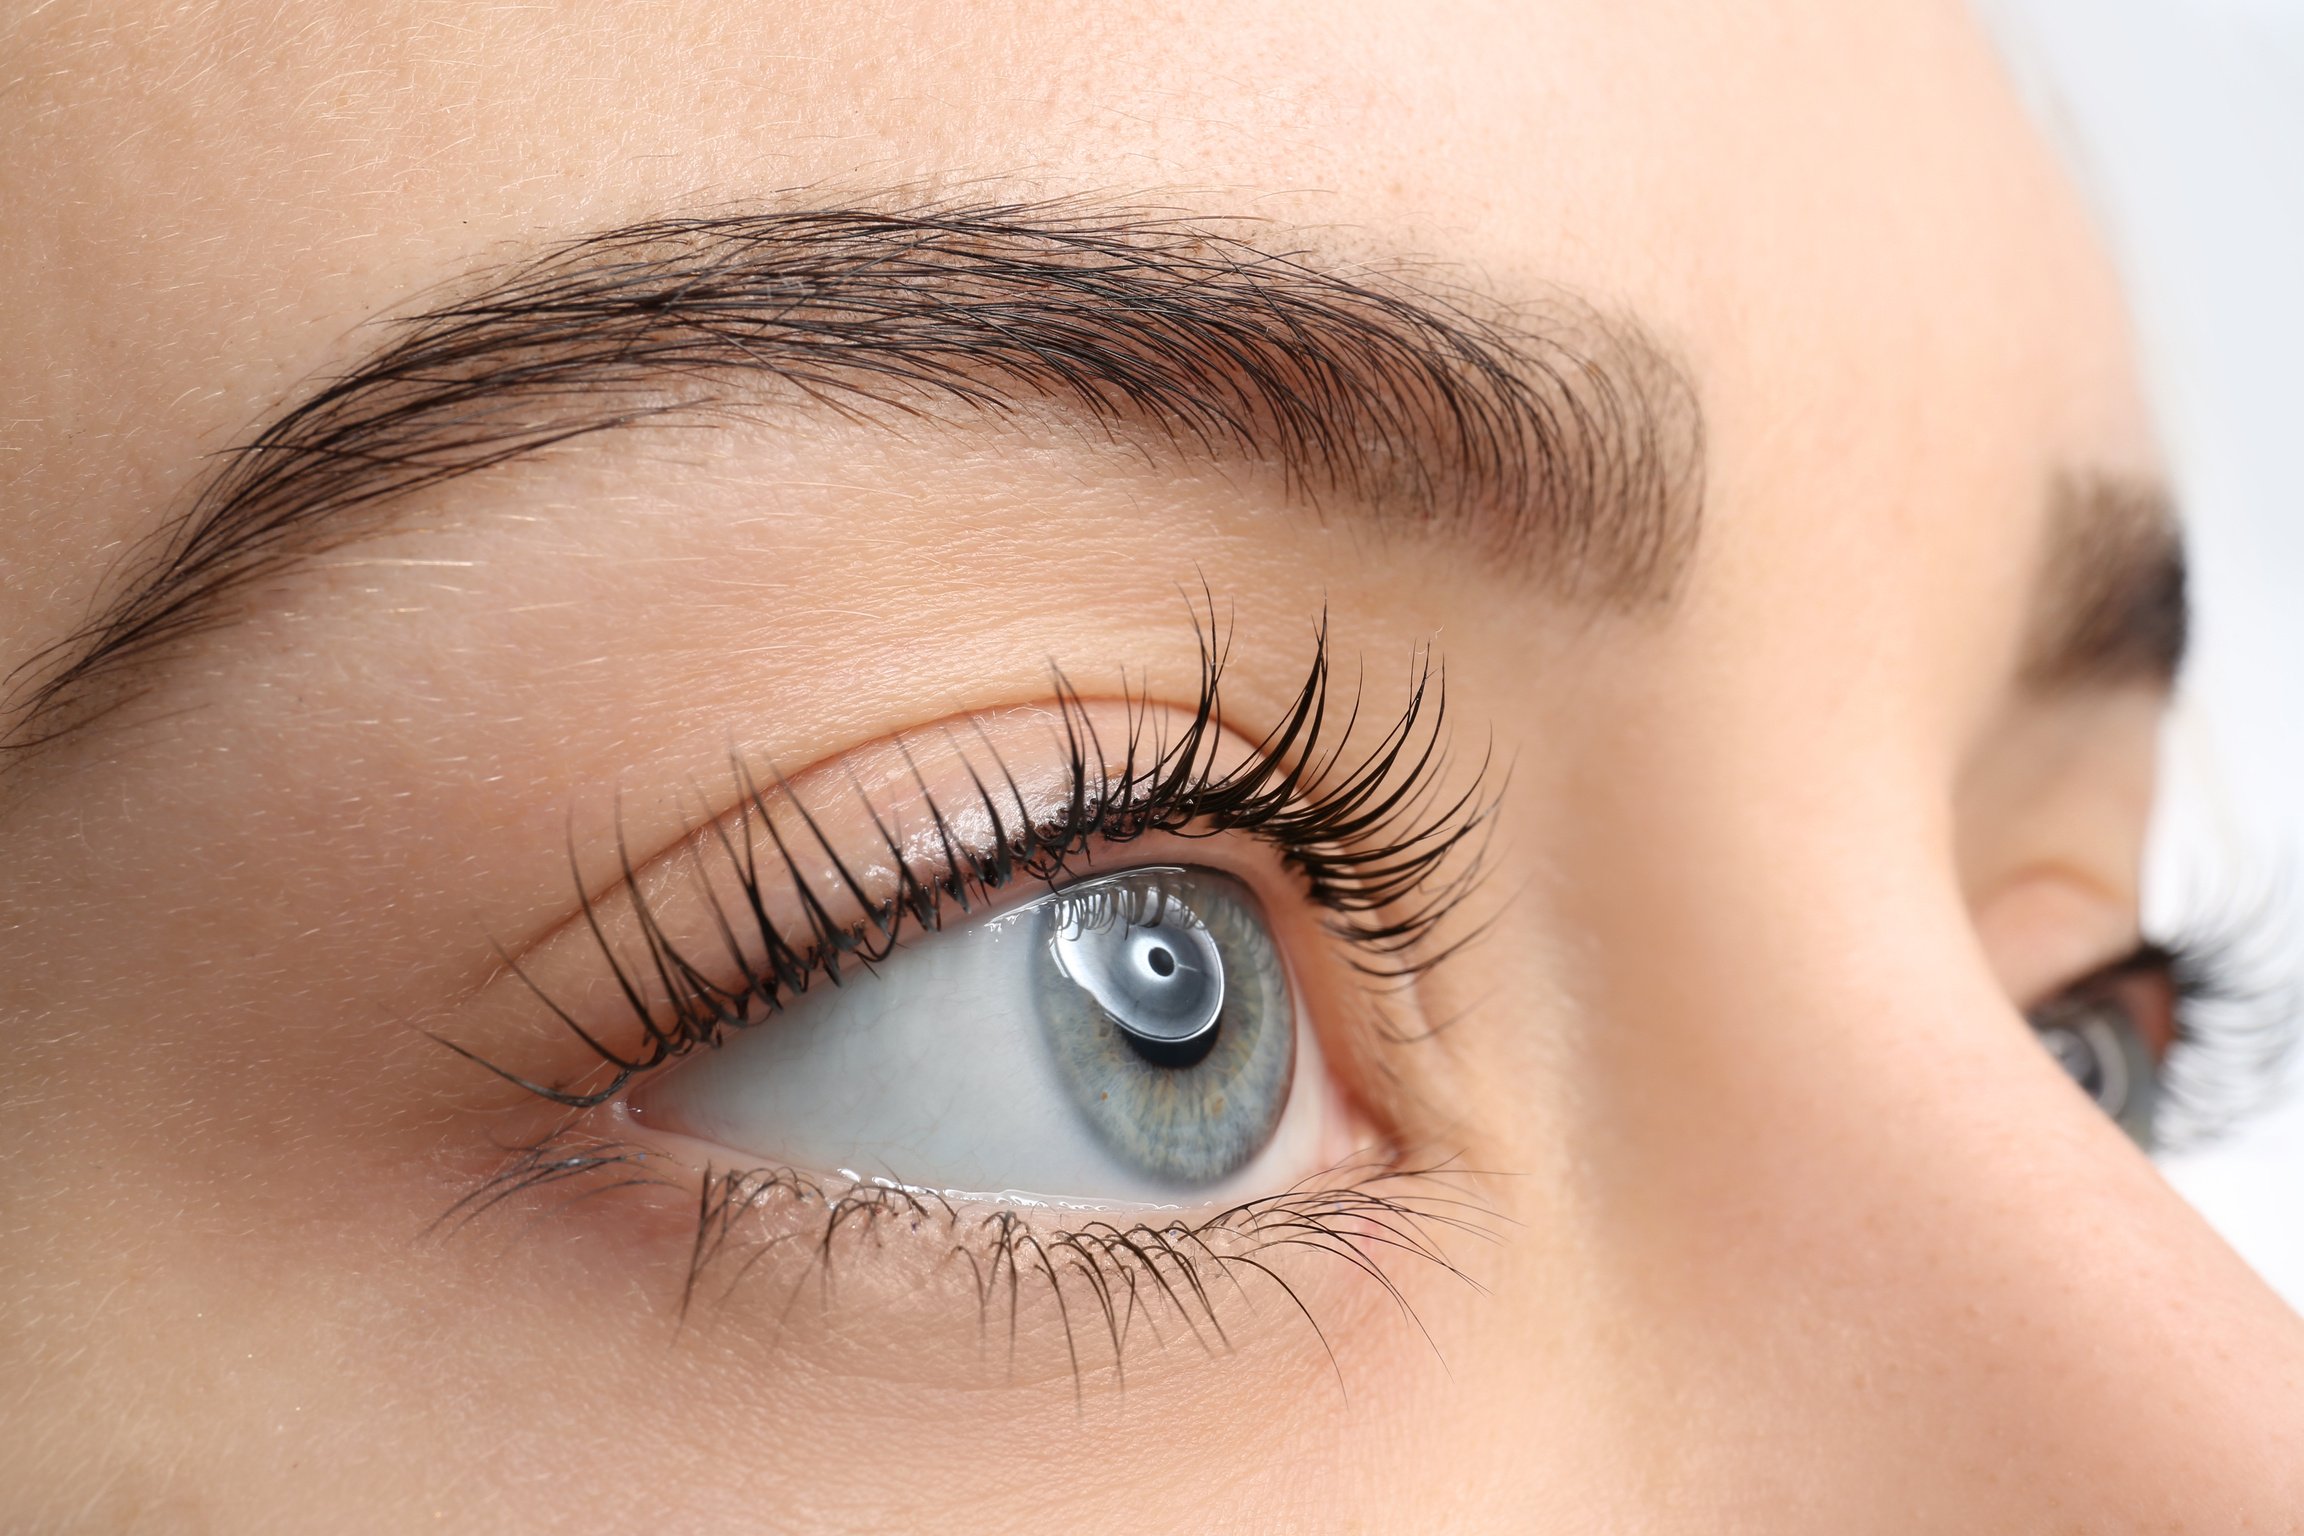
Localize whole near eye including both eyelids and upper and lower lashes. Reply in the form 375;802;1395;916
440;615;1498;1379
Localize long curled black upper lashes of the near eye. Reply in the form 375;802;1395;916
440;603;1498;1108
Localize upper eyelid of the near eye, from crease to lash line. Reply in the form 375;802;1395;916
458;723;1472;1108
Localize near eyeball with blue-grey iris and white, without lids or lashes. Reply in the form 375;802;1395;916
629;866;1325;1204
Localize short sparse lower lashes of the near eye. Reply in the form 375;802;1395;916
435;1124;1500;1398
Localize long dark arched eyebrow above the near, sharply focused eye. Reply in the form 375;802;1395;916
0;203;1703;746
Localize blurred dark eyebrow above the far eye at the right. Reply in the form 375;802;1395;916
2021;474;2191;693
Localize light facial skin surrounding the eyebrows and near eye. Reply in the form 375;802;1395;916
0;0;2304;1531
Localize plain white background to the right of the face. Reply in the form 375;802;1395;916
1984;0;2304;1306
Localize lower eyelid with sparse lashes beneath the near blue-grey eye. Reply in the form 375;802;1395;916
447;1119;1500;1393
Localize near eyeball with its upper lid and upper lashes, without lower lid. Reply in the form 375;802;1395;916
442;624;1495;1234
